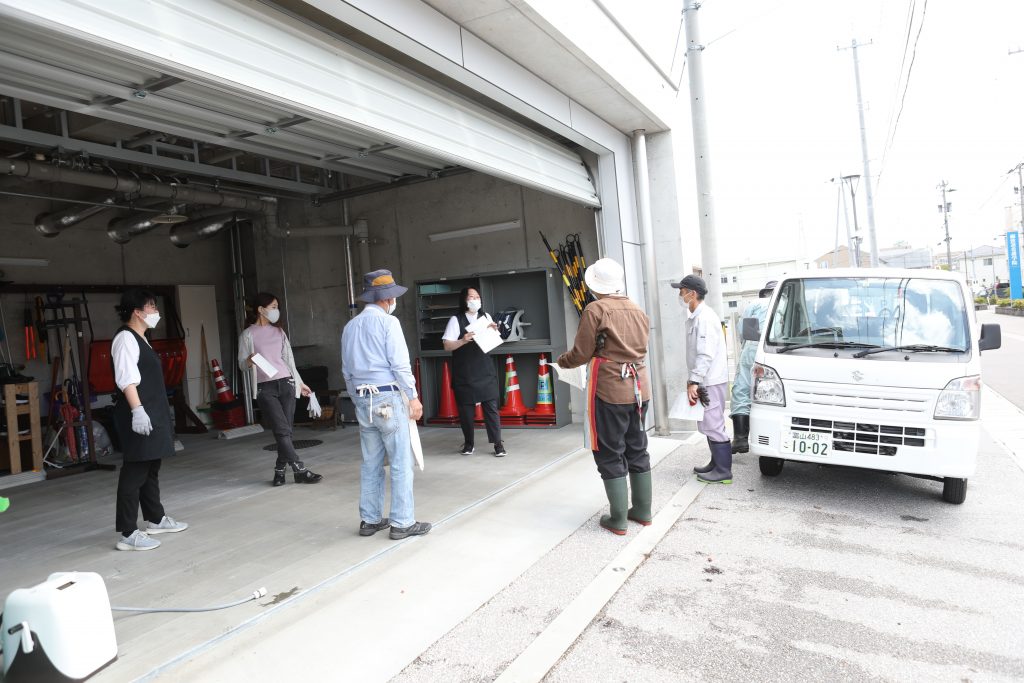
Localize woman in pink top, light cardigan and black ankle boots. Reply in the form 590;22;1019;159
239;292;324;486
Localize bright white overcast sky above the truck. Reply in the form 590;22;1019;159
681;0;1024;265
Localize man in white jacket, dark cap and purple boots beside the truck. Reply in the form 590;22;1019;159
672;275;732;483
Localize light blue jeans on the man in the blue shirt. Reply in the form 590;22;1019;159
352;391;416;527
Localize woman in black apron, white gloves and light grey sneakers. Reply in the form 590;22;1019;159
111;290;188;550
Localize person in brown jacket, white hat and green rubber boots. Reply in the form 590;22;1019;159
558;258;651;536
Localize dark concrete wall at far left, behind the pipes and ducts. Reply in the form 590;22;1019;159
0;181;234;403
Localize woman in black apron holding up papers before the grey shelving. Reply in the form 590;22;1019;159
441;287;507;458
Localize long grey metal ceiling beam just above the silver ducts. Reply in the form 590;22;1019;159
0;126;325;195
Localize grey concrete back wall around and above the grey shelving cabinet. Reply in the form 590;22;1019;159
256;173;598;388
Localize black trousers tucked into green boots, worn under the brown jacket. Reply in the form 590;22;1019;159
594;398;650;479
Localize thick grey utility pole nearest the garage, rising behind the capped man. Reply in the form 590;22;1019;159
683;0;724;316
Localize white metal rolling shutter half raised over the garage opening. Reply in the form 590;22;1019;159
0;0;600;207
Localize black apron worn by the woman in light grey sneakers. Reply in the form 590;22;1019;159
111;327;174;463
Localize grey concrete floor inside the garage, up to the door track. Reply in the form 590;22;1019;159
0;425;678;680
